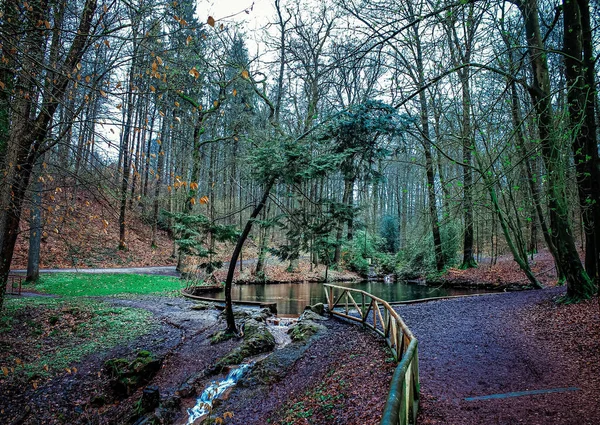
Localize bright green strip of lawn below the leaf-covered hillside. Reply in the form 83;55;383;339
25;273;185;297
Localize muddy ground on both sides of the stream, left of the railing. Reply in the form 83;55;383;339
0;296;395;425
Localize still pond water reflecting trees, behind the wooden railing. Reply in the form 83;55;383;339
214;281;490;315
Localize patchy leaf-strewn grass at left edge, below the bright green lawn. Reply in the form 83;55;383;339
0;298;155;384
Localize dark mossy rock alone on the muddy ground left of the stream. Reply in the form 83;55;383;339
104;351;162;397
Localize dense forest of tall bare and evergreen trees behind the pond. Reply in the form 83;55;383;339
0;0;600;301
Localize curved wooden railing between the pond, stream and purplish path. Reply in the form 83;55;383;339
323;284;420;425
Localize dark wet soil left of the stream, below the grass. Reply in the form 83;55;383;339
0;297;237;425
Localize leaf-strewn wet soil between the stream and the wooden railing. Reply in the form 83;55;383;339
215;319;396;425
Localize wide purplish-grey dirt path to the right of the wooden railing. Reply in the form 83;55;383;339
397;288;600;425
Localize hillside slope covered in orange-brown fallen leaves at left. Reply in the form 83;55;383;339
11;192;175;269
